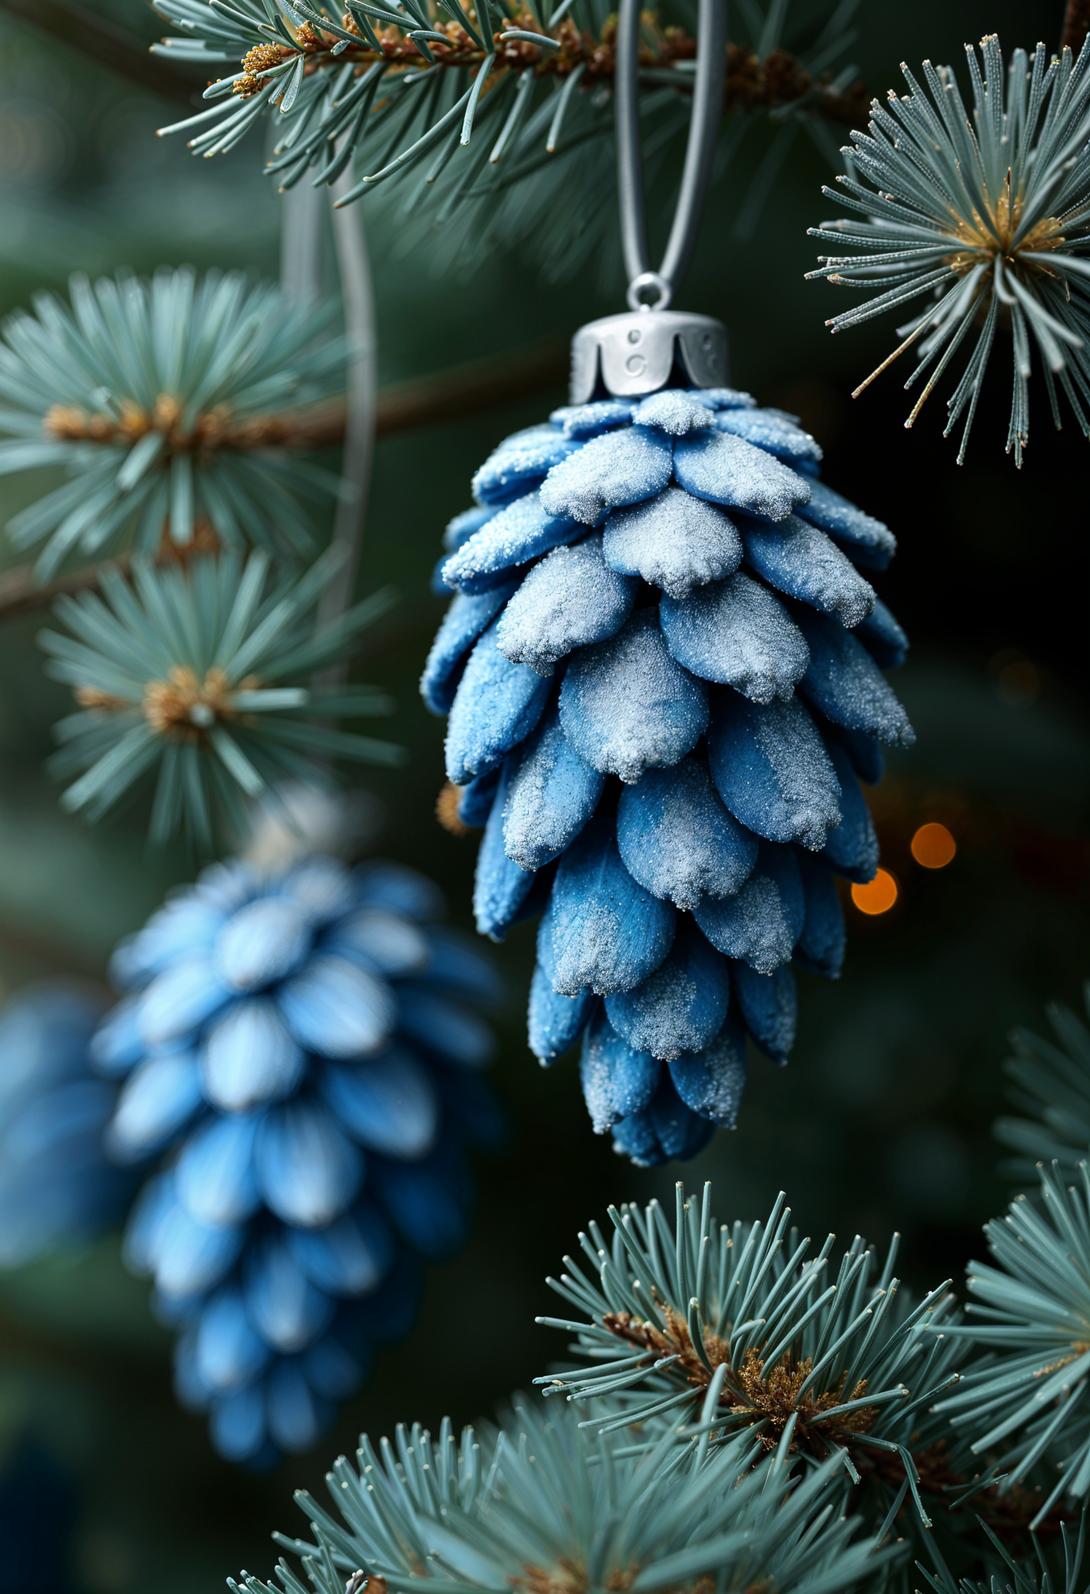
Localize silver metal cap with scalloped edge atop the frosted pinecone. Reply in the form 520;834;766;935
570;309;727;403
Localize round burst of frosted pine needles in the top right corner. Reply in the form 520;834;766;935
810;35;1090;465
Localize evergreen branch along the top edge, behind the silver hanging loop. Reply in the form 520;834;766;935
156;0;867;274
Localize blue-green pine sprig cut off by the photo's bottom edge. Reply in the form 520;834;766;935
231;1403;891;1594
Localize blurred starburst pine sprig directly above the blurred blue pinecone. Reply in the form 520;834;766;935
41;550;397;848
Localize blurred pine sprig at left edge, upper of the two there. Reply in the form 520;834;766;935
0;268;346;577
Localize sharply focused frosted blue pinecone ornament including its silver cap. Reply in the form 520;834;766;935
422;311;912;1165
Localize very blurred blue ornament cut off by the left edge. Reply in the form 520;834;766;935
0;980;132;1267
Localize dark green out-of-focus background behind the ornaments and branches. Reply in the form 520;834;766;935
0;0;1090;1594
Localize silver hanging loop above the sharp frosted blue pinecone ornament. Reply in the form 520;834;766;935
614;0;727;309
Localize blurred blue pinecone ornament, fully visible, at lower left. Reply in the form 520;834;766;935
96;854;496;1463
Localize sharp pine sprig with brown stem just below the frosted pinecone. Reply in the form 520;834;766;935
535;1186;1060;1540
